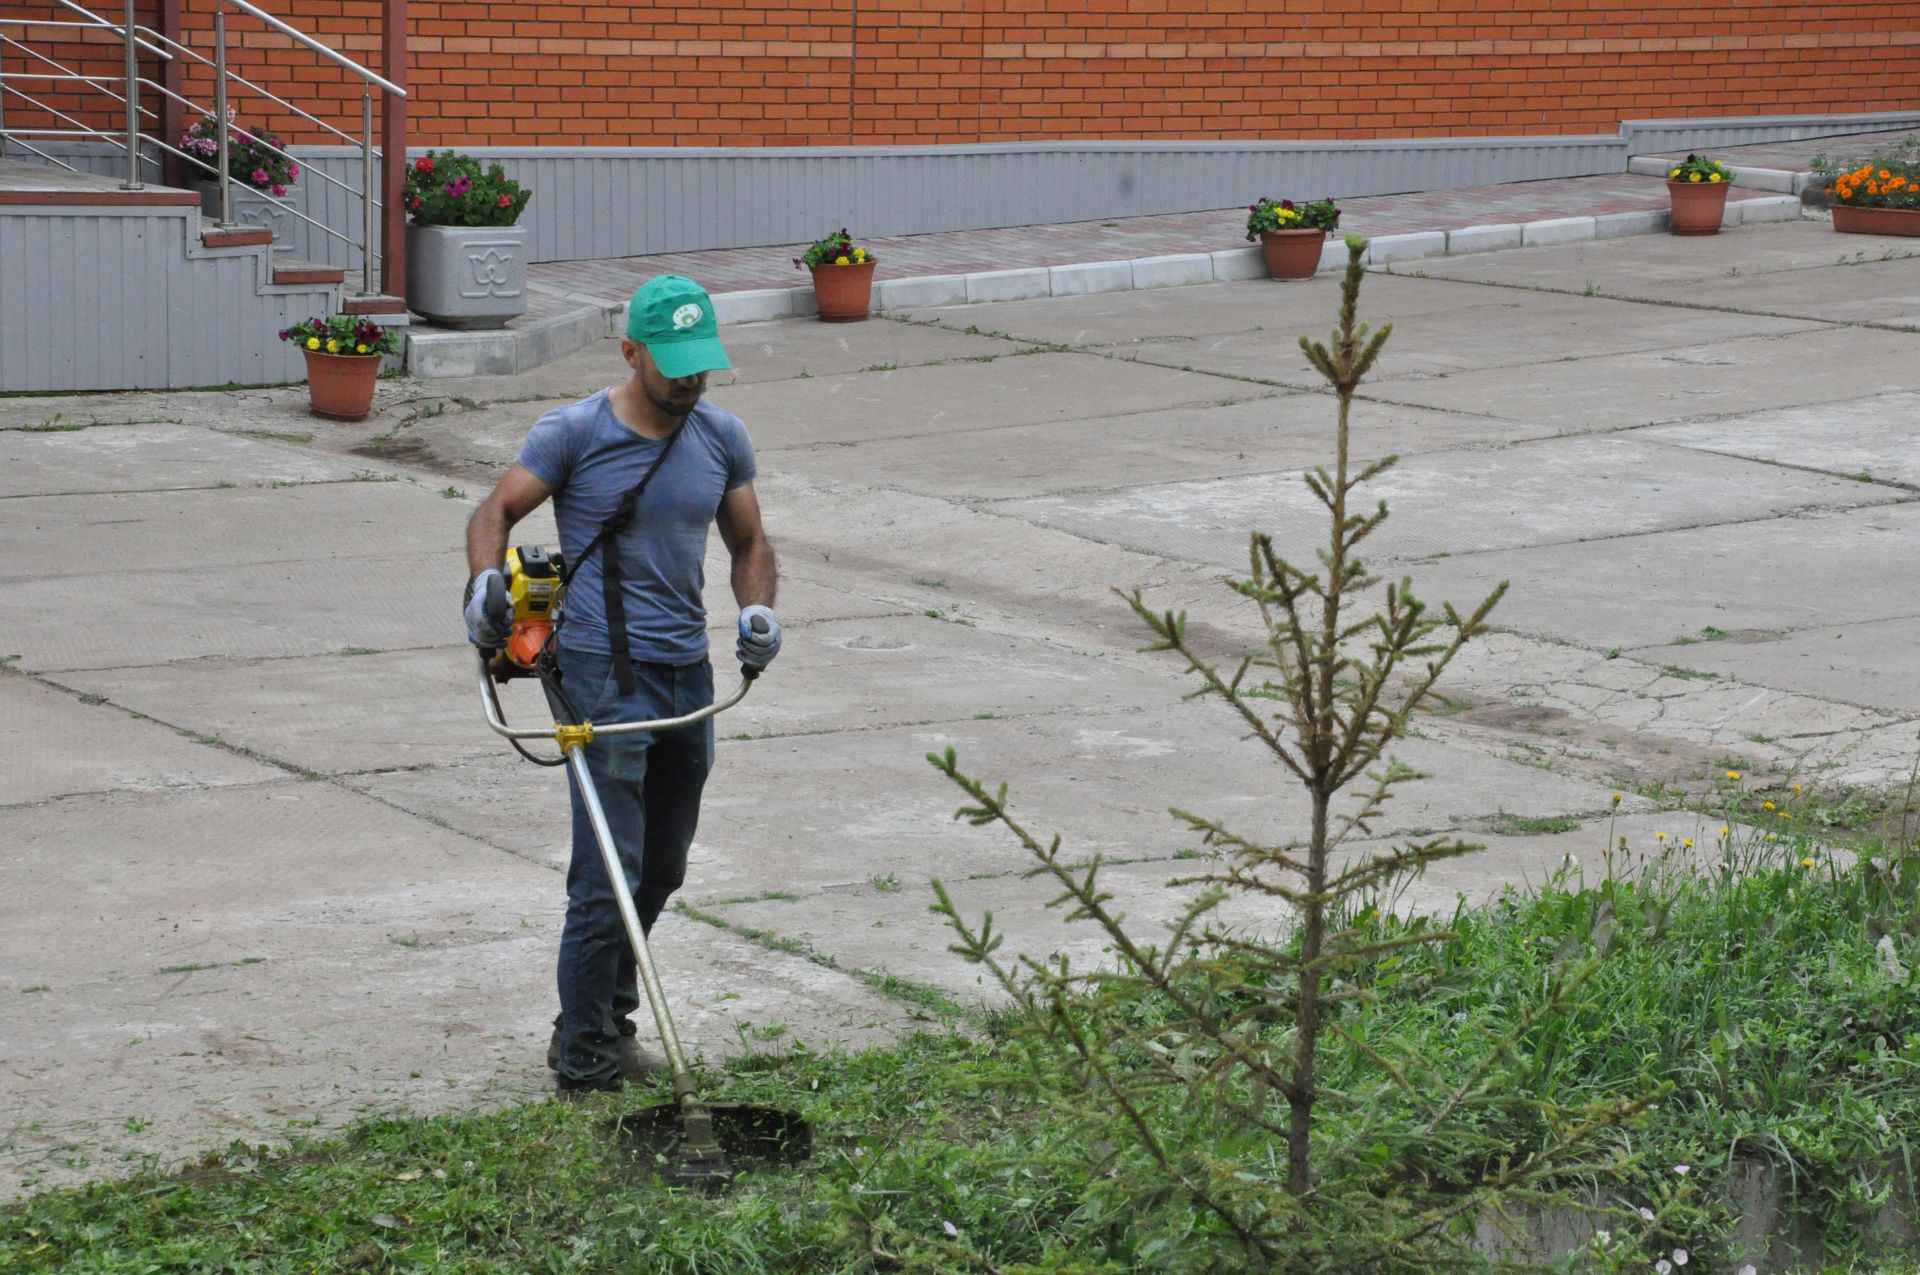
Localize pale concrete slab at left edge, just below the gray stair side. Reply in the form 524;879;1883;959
0;424;376;497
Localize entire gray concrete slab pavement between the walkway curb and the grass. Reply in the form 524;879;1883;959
0;209;1920;1192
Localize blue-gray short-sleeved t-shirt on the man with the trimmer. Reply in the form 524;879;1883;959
520;390;755;664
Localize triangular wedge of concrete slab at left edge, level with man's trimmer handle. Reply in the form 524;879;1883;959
0;674;284;806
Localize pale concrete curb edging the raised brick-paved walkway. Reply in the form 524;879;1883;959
407;192;1809;378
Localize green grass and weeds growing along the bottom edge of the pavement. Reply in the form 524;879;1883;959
15;821;1920;1275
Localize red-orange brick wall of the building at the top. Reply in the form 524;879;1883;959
15;0;1920;146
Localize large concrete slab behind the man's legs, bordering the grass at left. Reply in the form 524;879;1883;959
0;780;906;1194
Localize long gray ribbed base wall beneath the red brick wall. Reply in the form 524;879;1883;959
18;111;1920;266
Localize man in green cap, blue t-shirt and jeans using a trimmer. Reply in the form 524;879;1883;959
467;275;780;1095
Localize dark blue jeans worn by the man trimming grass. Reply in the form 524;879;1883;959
555;651;714;1081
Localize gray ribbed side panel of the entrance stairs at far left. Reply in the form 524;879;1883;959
0;205;338;391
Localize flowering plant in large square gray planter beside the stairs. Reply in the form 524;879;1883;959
405;150;534;328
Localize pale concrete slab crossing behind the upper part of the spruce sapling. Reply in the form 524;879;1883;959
995;430;1901;566
